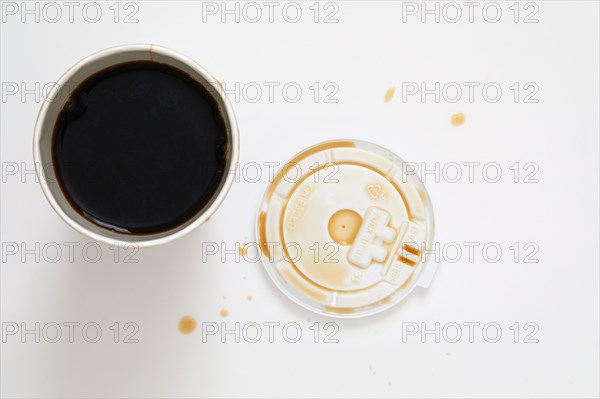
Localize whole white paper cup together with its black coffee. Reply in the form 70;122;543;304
34;45;239;246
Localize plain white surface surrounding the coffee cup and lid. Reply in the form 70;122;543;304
0;1;600;397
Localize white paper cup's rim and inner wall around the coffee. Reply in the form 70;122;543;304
33;44;239;247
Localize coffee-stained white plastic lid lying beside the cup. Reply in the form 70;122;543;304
257;140;433;317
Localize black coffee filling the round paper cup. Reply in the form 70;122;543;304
52;62;228;234
